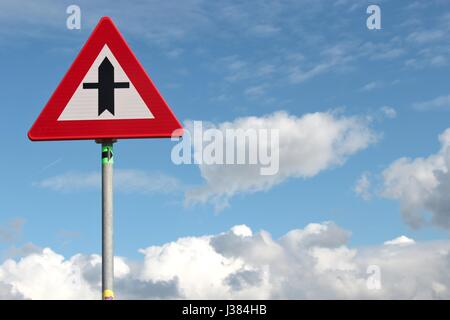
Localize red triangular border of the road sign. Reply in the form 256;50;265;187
28;17;183;141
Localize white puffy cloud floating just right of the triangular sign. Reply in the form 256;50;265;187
185;112;377;211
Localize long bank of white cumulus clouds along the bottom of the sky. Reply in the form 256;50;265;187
0;222;450;299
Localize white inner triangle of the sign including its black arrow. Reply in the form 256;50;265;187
58;45;154;121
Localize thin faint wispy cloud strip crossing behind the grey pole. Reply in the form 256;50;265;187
34;169;181;193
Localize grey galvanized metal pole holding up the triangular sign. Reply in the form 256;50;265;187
102;140;115;300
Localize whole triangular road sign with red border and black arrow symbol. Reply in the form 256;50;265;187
28;17;182;141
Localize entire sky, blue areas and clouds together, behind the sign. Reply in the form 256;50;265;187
0;0;450;299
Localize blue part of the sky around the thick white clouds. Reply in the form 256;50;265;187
0;0;450;300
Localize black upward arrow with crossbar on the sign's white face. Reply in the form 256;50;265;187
83;57;130;115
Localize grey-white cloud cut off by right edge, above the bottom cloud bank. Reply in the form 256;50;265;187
381;129;450;229
